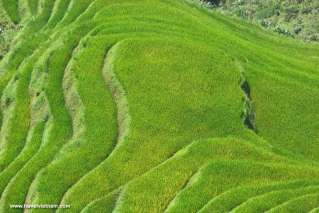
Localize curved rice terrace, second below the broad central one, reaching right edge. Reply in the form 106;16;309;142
166;161;317;212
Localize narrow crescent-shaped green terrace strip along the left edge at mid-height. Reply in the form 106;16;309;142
0;55;32;170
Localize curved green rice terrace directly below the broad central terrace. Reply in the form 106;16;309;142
116;138;286;212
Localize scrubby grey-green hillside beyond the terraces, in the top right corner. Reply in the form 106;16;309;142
205;0;319;41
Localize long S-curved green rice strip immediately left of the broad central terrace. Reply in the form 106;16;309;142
29;35;118;208
